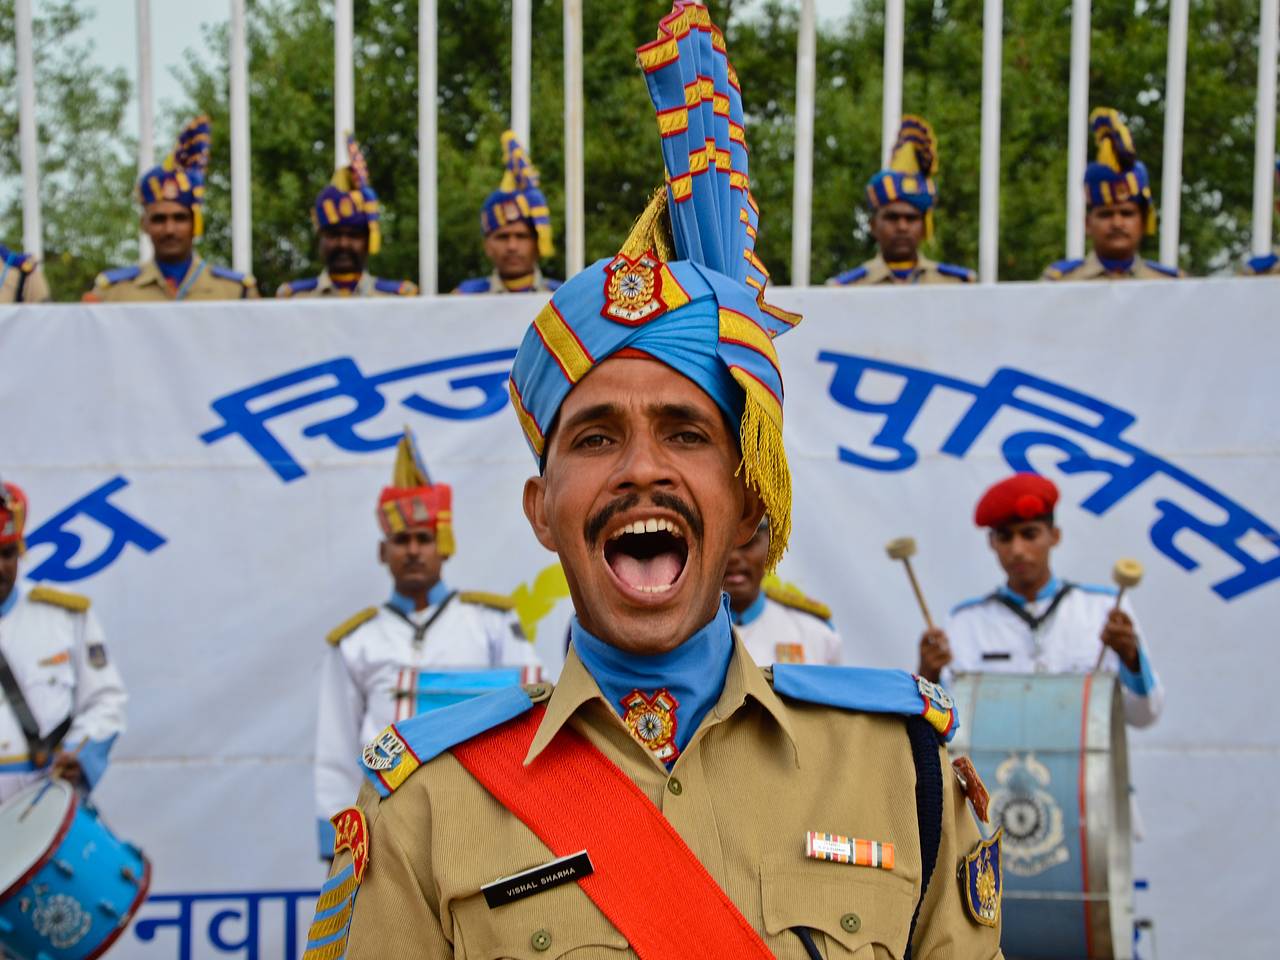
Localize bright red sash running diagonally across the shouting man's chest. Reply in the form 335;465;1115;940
453;705;773;960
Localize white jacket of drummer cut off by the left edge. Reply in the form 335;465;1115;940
0;584;128;803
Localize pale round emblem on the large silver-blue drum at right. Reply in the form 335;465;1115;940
991;754;1071;877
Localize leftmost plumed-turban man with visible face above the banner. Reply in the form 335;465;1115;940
82;116;257;303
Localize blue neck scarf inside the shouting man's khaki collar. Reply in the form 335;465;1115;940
571;595;733;768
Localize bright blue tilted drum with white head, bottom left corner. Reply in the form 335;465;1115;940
0;780;151;960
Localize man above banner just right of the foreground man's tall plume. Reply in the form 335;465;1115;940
827;114;975;287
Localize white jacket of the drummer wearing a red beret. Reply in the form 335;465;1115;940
942;577;1165;727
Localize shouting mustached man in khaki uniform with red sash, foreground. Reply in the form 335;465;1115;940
306;9;1001;960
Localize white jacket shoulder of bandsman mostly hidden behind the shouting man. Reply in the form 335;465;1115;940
730;589;844;667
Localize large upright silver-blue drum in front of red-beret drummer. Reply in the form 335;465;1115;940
951;673;1133;960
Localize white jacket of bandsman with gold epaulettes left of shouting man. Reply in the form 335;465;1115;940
315;582;541;856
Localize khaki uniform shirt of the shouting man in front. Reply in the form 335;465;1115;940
317;639;1001;960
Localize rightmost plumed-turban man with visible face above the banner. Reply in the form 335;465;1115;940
1041;106;1183;280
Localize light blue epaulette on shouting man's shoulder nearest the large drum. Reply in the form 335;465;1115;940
764;663;960;744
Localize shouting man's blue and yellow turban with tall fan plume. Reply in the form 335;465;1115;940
511;0;800;568
